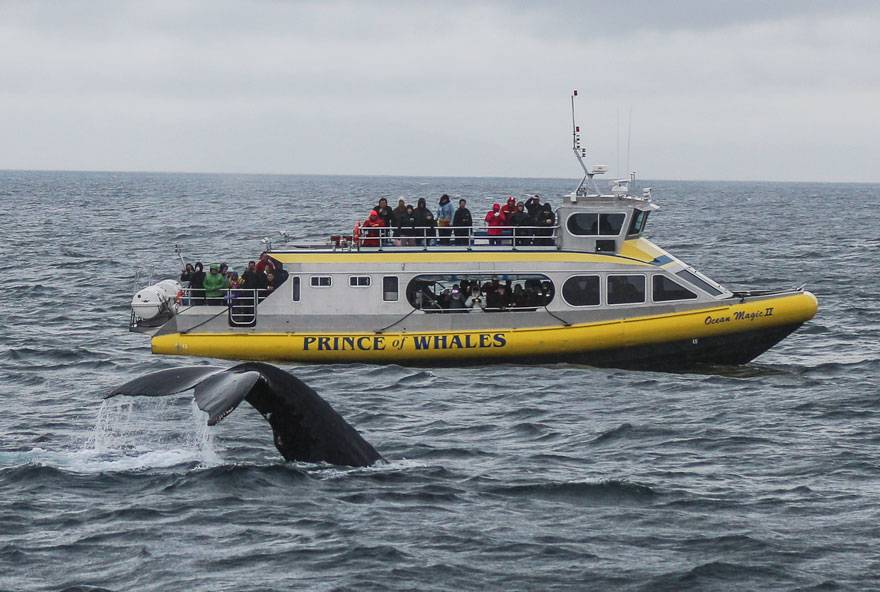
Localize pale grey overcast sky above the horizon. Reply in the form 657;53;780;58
0;0;880;182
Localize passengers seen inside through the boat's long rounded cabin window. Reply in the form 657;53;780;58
410;279;553;312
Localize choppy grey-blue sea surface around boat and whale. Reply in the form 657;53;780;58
0;172;880;591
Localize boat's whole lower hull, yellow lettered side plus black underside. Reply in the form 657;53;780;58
152;292;818;367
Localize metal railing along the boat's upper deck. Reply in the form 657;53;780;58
322;225;559;251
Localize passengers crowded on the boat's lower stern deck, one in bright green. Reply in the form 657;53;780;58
180;252;288;306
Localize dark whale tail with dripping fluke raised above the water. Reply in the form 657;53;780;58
105;362;382;467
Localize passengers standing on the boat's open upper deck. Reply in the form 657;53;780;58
356;193;556;247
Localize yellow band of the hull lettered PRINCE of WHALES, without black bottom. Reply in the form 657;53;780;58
152;292;818;364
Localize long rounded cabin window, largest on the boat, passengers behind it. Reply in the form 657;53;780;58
406;273;555;312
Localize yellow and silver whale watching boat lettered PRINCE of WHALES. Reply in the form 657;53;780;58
130;91;817;370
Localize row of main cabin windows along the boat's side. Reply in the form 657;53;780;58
293;269;722;308
